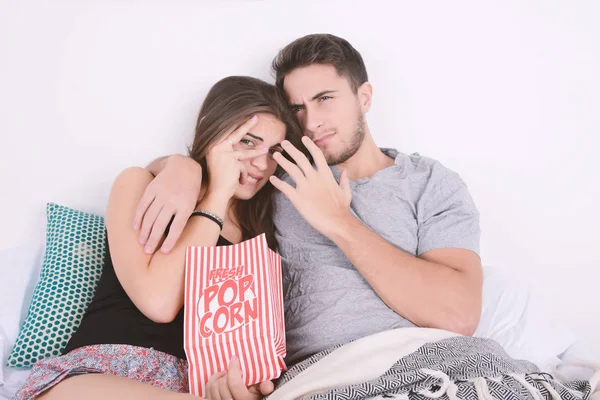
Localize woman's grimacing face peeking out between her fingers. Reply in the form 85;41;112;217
233;114;286;200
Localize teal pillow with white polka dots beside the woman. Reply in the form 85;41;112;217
7;203;105;367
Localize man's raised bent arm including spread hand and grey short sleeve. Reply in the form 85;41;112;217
271;137;482;335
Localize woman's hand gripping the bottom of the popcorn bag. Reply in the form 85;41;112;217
206;358;275;400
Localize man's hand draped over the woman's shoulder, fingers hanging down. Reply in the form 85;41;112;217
133;155;202;254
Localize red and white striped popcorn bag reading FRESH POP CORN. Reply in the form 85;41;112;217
184;234;286;396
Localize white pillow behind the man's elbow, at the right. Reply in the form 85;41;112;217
473;267;576;372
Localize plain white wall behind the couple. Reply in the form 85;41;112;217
0;0;600;344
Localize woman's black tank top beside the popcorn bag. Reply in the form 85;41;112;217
62;231;231;360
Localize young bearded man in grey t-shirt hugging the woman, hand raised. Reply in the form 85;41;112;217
136;34;483;398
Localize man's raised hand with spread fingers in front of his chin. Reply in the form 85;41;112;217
270;136;352;237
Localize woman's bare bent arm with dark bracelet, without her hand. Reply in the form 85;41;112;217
105;167;229;323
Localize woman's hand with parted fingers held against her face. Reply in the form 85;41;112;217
206;115;266;200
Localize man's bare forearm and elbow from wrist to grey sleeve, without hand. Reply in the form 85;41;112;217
326;213;483;336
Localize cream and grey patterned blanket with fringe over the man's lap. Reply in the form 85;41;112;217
268;328;600;400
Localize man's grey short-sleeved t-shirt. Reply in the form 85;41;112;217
274;149;480;365
